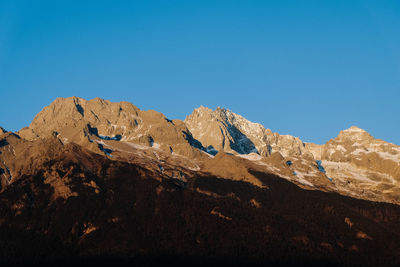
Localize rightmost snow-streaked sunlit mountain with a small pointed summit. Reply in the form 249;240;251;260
307;126;400;203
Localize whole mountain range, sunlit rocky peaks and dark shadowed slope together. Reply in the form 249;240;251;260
0;97;400;266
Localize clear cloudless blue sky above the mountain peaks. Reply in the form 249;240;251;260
0;0;400;145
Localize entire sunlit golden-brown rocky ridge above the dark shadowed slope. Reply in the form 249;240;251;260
3;97;400;203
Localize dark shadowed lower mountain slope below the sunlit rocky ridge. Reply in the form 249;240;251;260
0;141;400;265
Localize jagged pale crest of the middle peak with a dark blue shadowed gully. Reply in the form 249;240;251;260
185;107;310;157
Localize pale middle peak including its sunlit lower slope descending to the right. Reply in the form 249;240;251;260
185;107;335;191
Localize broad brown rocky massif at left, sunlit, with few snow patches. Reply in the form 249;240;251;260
18;97;203;158
